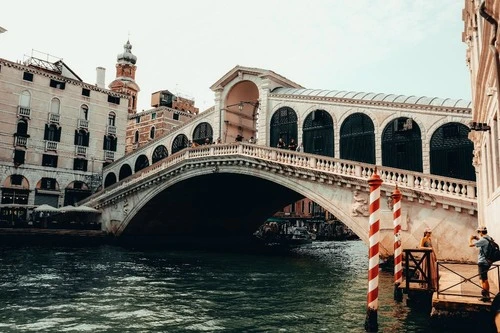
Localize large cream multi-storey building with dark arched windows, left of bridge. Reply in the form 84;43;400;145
0;53;130;226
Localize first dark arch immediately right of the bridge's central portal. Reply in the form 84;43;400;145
270;106;297;147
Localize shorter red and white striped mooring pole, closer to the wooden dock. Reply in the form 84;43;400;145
392;185;403;301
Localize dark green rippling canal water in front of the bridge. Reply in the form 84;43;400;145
0;241;484;332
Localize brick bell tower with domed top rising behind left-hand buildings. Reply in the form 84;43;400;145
109;40;141;114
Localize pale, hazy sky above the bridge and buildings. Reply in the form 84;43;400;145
0;0;471;111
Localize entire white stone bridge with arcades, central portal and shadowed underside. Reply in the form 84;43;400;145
82;66;477;260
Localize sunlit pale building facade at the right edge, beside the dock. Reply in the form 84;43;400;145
462;0;500;239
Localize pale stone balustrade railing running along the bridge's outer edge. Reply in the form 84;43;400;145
83;142;477;204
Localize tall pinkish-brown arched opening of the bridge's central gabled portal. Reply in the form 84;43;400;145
225;80;259;142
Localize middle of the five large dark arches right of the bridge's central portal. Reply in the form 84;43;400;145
340;112;375;164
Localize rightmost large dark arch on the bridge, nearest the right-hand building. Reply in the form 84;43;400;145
430;123;476;181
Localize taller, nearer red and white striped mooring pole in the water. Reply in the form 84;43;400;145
365;167;382;332
